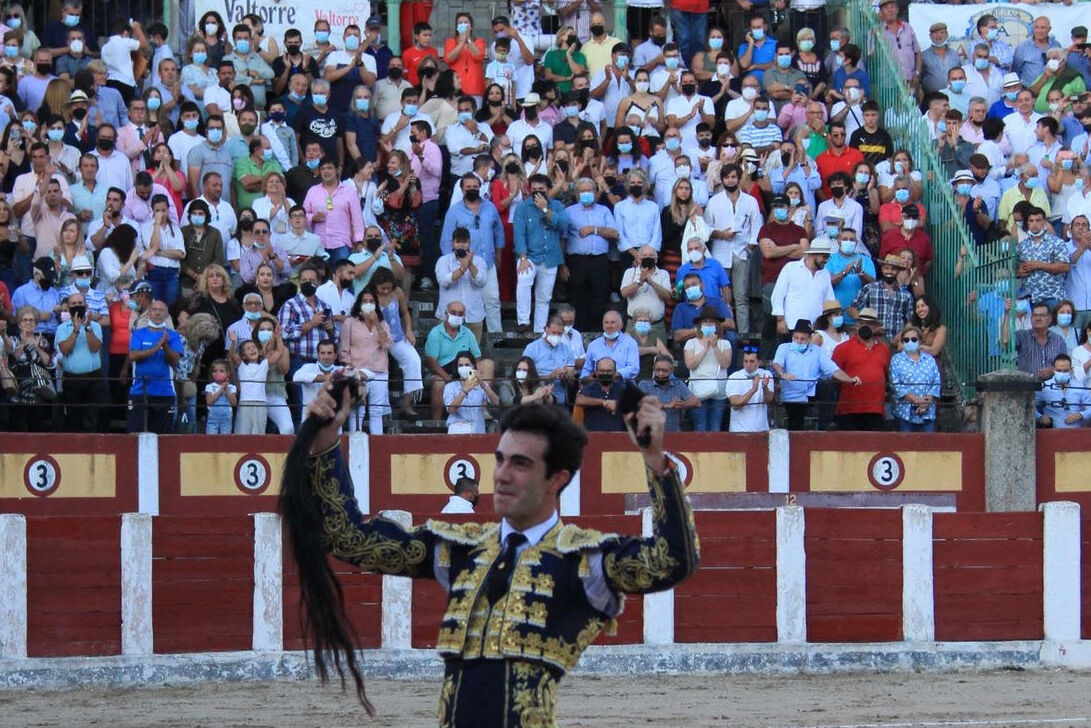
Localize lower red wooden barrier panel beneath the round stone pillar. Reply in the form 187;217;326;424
933;513;1043;642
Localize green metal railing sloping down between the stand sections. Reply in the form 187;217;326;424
842;0;1018;398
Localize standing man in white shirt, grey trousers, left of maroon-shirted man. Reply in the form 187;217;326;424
705;165;765;336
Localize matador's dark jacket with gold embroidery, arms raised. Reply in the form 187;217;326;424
312;447;698;673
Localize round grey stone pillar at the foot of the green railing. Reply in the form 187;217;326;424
978;370;1039;512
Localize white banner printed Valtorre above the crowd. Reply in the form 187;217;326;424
193;0;371;50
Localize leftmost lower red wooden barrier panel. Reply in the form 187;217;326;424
26;516;121;657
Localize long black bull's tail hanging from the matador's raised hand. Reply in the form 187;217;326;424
277;379;375;716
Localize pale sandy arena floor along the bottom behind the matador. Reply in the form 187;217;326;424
0;671;1091;728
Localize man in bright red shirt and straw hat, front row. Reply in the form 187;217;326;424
832;309;897;432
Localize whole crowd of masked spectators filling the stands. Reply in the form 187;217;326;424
0;0;1091;434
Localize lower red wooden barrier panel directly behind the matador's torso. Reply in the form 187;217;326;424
412;515;644;648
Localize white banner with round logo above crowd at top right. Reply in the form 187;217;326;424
909;2;1091;56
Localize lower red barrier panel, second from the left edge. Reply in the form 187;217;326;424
152;516;254;653
